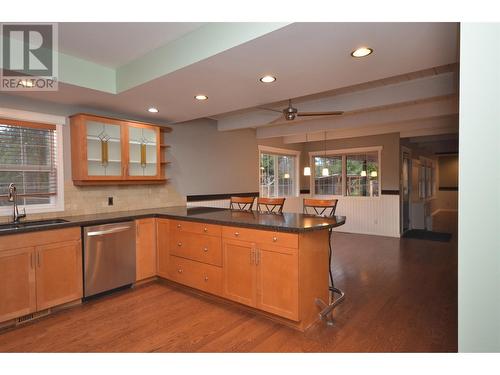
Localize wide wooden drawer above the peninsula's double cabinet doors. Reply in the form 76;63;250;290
222;227;299;249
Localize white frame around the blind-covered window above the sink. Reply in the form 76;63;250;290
0;107;66;217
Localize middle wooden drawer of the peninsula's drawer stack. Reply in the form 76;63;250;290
170;232;222;266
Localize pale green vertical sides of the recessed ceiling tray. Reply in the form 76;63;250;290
0;22;289;94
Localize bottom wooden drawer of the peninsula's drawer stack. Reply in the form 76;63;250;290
168;255;222;295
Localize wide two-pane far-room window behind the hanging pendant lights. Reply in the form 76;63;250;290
310;147;382;197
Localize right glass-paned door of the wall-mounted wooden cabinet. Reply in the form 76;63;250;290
128;125;160;178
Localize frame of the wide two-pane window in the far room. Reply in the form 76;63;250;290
309;146;383;199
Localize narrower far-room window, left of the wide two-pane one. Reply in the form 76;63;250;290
259;146;300;197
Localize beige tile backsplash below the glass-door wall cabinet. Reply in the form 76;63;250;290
0;181;186;222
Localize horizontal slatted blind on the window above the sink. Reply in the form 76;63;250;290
0;118;57;206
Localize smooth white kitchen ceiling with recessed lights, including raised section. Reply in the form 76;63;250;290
4;23;458;128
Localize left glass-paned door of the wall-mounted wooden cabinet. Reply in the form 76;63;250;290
85;119;125;180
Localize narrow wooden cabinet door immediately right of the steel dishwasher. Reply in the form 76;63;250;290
135;219;156;280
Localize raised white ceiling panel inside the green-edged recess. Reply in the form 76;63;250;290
58;22;203;68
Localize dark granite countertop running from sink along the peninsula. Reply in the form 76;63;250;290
0;206;346;236
